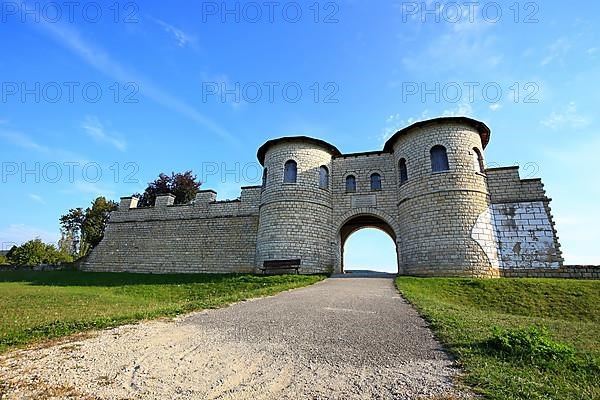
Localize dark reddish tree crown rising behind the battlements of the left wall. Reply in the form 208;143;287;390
134;171;201;207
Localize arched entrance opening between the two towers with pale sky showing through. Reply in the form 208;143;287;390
338;215;399;273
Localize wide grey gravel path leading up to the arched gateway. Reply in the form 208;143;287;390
0;277;466;400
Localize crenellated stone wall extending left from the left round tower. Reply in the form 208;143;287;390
81;187;260;273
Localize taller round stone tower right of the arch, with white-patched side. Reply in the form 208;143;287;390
384;117;499;277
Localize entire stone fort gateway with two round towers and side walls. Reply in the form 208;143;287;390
81;117;563;277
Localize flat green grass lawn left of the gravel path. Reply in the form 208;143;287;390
0;271;324;352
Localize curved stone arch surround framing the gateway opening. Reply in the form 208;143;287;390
335;209;402;273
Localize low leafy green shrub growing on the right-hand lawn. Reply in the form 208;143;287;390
487;326;575;365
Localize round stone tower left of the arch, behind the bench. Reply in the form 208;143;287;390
256;136;340;273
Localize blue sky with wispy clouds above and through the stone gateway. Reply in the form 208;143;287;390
0;0;600;266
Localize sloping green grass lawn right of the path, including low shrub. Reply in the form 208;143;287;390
396;277;600;400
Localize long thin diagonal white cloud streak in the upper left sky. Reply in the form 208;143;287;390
27;8;239;145
